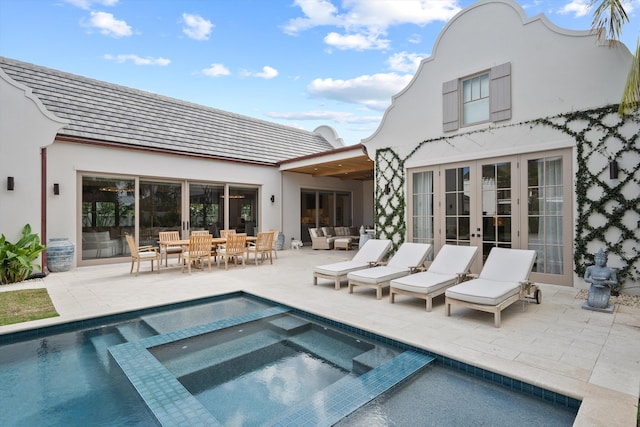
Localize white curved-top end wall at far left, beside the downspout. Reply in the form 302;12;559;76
0;69;66;242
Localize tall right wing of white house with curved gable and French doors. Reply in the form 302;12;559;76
363;0;640;287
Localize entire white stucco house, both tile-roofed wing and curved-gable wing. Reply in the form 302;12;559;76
0;0;640;292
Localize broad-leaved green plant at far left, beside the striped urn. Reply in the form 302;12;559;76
0;224;46;285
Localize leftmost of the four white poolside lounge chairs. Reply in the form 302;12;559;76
313;239;391;289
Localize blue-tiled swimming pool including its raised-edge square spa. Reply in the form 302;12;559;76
0;293;579;425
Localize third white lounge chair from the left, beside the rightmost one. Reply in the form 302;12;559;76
389;245;478;311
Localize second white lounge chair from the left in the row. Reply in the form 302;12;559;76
347;243;433;299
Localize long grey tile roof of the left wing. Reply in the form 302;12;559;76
0;57;334;165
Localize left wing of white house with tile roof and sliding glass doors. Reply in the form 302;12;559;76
0;58;373;266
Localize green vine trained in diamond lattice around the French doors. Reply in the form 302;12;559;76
375;105;640;290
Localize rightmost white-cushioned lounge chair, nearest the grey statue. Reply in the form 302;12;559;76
445;247;540;328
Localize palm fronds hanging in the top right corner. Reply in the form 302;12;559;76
589;0;640;115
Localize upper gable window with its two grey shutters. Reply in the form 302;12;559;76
442;62;511;132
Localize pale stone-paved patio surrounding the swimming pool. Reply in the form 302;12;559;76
0;248;640;427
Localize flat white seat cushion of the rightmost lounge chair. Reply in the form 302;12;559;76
445;280;520;305
